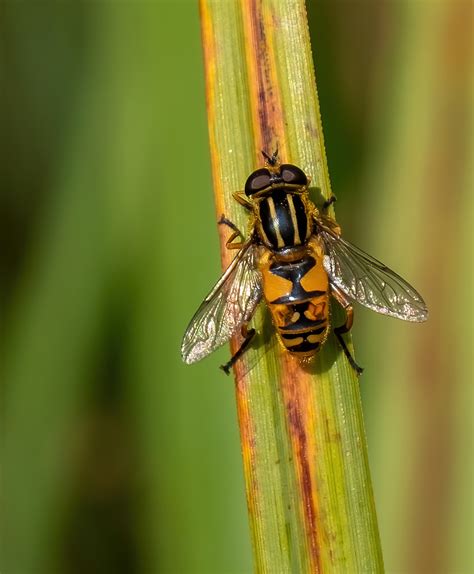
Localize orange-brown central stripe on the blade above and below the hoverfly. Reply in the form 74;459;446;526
243;0;322;572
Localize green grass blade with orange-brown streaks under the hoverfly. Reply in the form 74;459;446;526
201;0;383;573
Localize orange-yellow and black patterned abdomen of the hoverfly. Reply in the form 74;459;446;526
260;238;329;356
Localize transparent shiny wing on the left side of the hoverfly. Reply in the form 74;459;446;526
181;240;262;364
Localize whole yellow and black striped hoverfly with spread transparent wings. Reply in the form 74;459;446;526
181;150;428;374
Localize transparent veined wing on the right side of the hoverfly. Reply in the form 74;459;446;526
318;224;428;322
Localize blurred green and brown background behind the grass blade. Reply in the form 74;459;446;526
0;0;474;574
